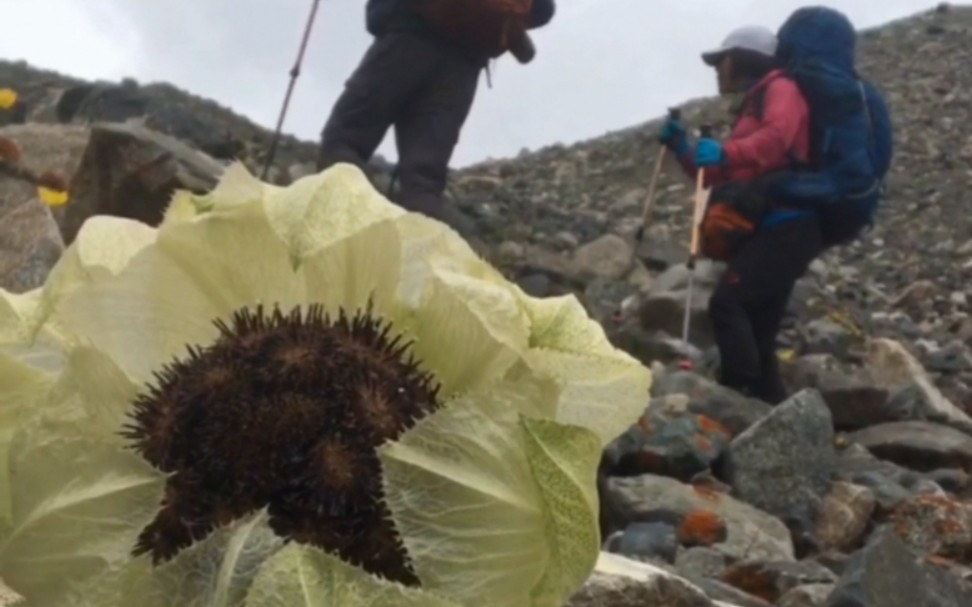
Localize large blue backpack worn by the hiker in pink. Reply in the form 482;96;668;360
768;6;893;247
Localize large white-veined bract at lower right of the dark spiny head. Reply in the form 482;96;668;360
379;388;601;607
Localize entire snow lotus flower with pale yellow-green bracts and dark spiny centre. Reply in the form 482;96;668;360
0;165;650;607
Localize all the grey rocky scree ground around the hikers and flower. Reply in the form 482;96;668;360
0;6;972;607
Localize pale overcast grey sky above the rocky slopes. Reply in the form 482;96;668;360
0;0;944;166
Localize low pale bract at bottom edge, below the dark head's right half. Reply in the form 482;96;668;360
246;544;461;607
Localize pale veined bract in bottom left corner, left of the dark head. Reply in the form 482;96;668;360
0;421;163;605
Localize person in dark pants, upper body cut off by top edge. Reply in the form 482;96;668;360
318;0;555;233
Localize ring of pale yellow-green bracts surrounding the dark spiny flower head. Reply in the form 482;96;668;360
0;165;651;607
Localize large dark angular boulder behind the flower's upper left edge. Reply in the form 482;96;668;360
61;123;225;244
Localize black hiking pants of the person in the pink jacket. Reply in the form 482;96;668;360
709;215;823;405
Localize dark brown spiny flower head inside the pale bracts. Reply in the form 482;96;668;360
124;306;439;584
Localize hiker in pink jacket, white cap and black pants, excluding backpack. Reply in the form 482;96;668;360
661;26;822;404
